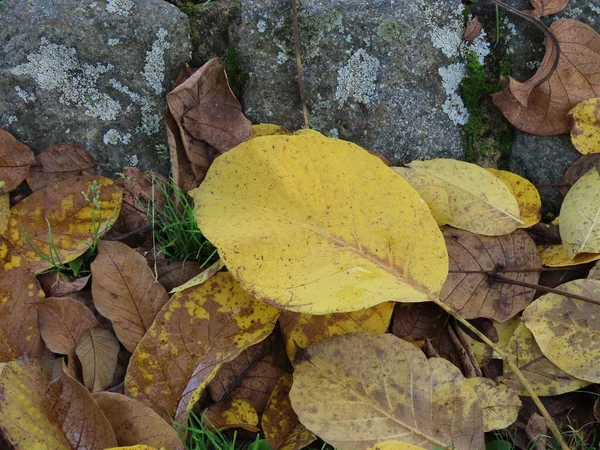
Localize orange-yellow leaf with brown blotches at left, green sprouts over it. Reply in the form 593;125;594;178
0;175;122;272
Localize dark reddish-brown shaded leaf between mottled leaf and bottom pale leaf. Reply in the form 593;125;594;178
208;335;291;414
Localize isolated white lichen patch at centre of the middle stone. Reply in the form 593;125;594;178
335;48;381;105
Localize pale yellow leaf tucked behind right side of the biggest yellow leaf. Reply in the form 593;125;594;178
397;158;523;236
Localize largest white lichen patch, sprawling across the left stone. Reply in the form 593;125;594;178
10;38;121;120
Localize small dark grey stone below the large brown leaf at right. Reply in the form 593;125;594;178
509;132;581;215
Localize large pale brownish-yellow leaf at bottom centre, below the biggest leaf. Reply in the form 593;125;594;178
290;333;484;450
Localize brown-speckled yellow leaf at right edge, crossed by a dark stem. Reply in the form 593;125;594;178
523;280;600;383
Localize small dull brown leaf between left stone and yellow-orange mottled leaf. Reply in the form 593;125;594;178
27;144;96;191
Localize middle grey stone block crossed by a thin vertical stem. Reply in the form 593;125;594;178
236;0;466;164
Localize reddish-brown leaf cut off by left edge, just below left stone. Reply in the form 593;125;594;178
0;130;35;194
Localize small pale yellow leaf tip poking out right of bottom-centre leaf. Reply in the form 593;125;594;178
466;377;521;433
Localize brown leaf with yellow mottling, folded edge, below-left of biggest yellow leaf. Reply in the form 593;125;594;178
125;272;279;421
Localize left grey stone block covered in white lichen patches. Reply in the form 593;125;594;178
0;0;190;175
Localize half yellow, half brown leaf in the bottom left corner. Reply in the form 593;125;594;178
0;360;117;450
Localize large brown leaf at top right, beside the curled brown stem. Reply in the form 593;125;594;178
492;19;600;136
